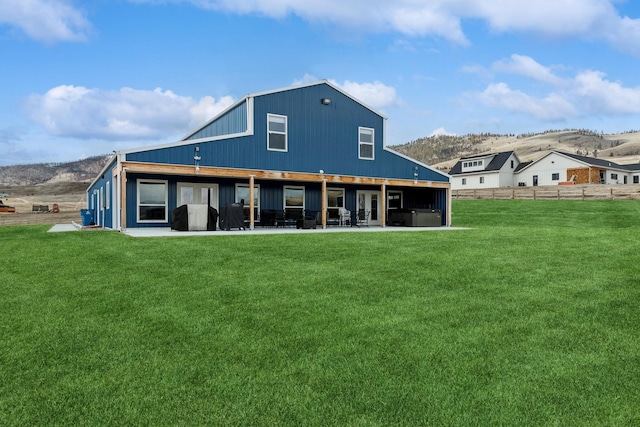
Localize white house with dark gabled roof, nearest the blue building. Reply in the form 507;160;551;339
449;151;521;190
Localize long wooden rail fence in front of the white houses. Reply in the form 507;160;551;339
451;184;640;200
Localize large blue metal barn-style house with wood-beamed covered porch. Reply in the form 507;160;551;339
87;81;451;230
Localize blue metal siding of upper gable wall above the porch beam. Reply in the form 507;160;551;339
122;84;449;182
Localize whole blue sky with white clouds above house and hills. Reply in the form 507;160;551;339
0;0;640;166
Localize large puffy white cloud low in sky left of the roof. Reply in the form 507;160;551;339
25;85;233;140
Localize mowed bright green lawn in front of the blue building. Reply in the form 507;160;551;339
0;200;640;426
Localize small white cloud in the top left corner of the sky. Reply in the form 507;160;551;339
0;0;91;43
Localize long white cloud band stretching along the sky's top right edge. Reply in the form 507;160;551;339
135;0;640;55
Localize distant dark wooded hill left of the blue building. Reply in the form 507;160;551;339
0;154;111;186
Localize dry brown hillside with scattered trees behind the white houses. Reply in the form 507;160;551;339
389;129;640;171
